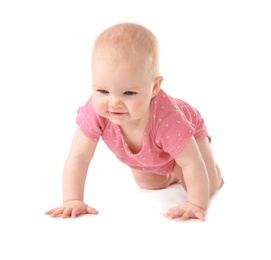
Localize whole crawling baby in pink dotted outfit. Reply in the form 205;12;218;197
45;23;223;220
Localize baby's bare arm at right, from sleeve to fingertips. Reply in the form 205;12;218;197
166;137;210;220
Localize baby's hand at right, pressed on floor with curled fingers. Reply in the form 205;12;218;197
165;202;205;221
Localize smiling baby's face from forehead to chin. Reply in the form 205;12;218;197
92;57;160;125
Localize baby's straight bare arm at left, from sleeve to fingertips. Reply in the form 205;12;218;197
45;128;98;218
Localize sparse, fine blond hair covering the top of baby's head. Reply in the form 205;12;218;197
92;23;160;77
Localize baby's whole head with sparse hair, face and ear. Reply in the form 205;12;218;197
91;23;163;127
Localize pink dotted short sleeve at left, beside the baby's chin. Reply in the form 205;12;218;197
76;97;107;141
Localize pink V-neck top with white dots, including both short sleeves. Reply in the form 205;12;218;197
76;90;210;175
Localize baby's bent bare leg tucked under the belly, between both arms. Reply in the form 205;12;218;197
132;169;178;190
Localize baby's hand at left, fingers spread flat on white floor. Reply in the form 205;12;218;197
45;200;99;218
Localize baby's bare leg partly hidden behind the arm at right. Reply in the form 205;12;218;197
174;137;224;196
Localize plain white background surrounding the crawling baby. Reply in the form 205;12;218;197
0;0;271;260
